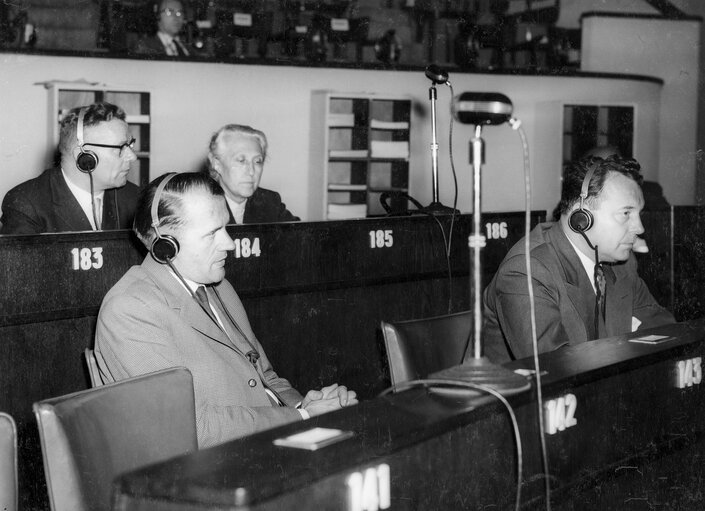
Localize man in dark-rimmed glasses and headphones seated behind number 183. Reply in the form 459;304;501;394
0;103;138;234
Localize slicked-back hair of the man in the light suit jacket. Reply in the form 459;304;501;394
132;172;225;248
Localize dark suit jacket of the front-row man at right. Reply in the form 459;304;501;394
483;223;675;363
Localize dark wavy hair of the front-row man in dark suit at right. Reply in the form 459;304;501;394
554;155;644;220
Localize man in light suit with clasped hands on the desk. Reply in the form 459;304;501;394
95;173;357;447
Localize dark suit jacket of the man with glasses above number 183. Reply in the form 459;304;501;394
0;168;138;234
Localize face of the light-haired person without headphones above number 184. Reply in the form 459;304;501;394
211;132;264;203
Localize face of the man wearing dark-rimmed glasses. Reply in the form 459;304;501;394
80;119;137;191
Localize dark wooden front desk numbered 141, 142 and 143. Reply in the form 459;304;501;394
116;322;705;511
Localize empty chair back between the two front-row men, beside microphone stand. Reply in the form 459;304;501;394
382;311;472;385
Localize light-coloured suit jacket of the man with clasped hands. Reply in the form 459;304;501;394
95;255;302;447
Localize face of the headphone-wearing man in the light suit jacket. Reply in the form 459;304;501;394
172;190;235;284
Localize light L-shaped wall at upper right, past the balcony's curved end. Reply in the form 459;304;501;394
581;16;701;205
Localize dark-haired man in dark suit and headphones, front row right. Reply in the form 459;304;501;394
484;156;675;363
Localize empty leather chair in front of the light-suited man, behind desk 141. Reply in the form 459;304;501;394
33;367;197;511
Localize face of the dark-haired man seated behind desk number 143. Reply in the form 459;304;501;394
586;172;644;262
